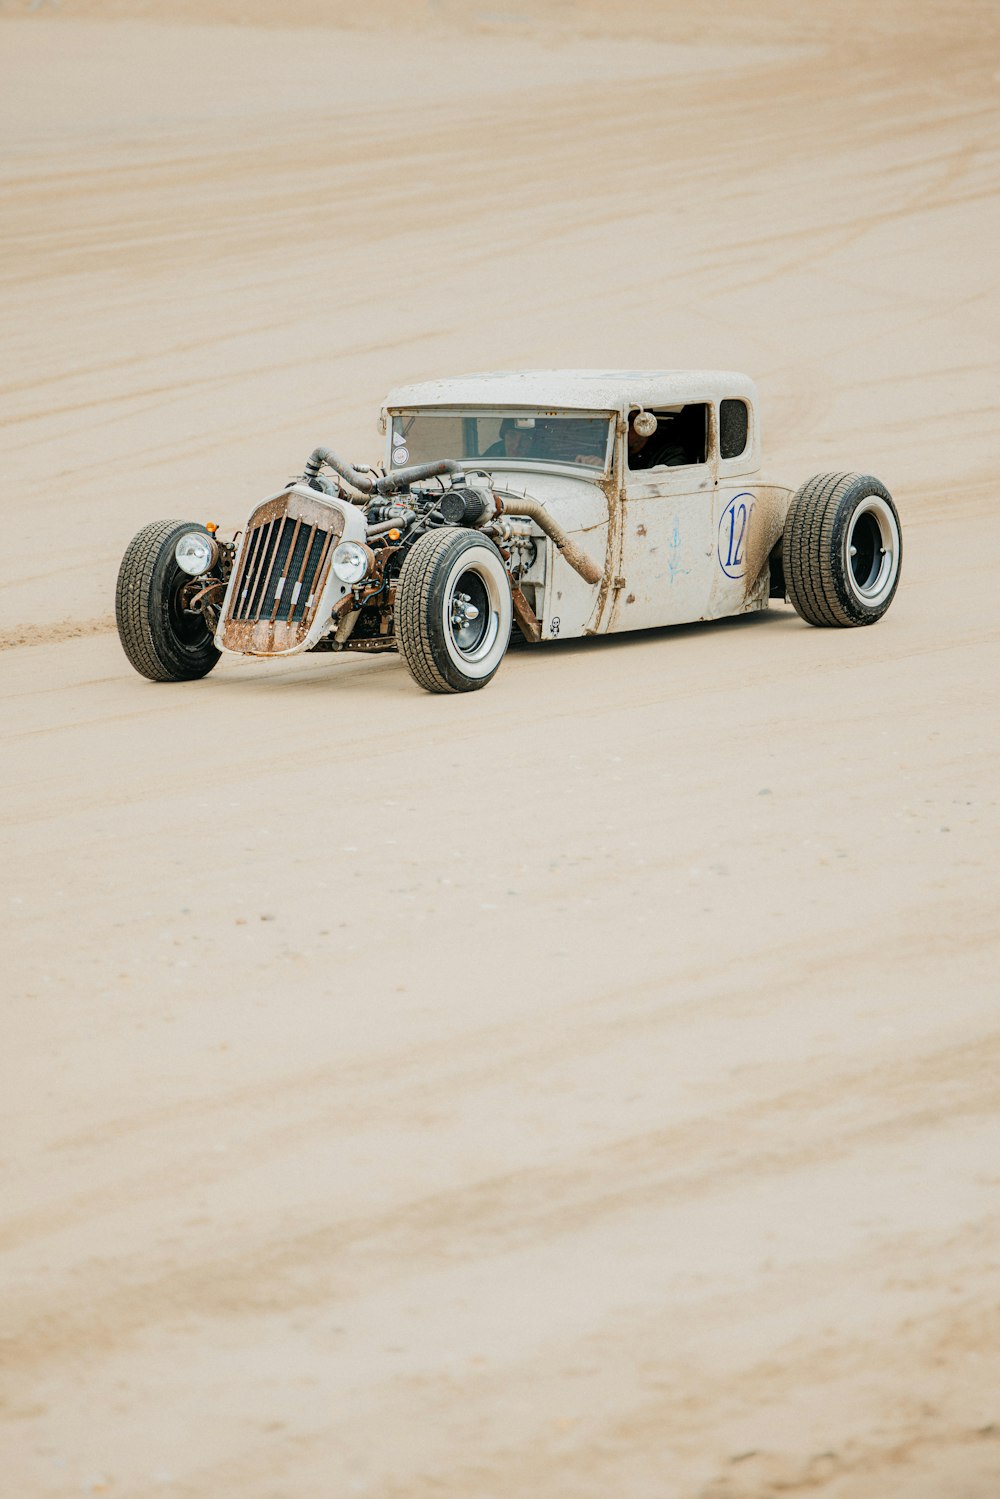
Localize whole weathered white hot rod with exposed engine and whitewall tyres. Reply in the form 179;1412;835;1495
115;370;903;693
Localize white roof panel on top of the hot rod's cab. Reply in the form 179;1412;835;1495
384;362;757;412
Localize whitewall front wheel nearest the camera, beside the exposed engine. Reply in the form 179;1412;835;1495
396;528;513;693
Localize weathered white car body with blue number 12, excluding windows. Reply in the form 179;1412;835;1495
382;370;793;640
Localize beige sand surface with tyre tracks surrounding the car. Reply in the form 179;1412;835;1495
0;0;1000;1499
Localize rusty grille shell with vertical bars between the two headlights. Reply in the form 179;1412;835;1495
219;490;343;657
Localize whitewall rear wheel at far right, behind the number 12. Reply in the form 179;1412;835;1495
781;474;903;628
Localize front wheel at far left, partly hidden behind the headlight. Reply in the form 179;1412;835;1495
114;520;219;682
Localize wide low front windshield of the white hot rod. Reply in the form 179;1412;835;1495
390;406;613;472
